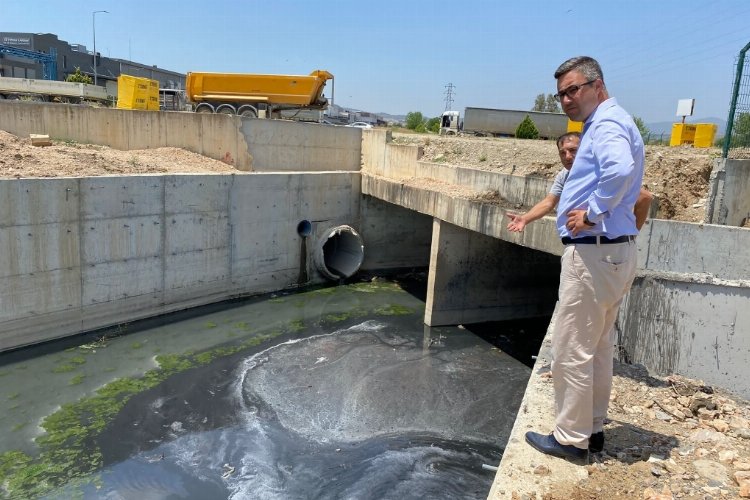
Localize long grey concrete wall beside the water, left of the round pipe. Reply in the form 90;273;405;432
0;172;360;350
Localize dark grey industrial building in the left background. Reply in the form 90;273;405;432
0;32;185;89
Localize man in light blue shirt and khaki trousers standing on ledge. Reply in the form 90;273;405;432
526;56;644;460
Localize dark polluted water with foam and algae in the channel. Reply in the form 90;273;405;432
0;281;529;500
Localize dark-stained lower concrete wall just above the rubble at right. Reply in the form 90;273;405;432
618;272;750;397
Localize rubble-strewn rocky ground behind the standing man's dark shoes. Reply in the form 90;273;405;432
536;364;750;500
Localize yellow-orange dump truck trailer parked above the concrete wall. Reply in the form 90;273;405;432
185;70;333;118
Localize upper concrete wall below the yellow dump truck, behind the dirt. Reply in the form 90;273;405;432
0;101;362;172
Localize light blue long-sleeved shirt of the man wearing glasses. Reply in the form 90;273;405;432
557;98;645;238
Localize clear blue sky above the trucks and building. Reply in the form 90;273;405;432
5;0;750;123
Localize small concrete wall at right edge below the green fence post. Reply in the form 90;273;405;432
705;158;750;227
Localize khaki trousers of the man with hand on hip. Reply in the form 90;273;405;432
552;241;636;449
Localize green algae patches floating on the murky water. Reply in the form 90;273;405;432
0;282;414;498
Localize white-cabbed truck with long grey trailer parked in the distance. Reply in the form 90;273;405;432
440;108;578;139
